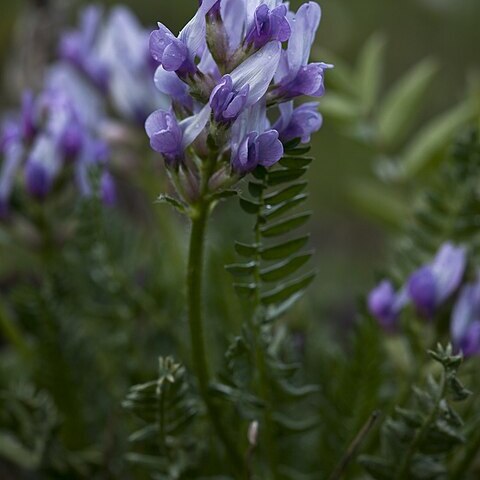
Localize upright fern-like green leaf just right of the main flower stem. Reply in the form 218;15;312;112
214;141;318;479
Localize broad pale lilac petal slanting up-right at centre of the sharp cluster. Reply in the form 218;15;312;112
231;42;282;107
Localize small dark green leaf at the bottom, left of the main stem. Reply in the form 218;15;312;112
123;357;199;480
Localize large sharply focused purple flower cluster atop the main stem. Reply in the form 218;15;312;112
145;0;331;183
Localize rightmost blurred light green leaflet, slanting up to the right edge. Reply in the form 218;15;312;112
399;101;476;180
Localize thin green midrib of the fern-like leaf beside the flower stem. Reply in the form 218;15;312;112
253;185;279;480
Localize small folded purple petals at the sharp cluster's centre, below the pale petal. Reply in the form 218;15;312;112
210;75;250;123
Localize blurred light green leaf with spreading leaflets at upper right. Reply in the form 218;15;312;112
319;35;479;230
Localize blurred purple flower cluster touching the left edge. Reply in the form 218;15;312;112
0;64;115;217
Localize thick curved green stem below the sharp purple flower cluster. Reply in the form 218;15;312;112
187;189;244;475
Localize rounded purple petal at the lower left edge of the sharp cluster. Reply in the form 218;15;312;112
145;110;183;160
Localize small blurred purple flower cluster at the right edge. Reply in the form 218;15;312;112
368;243;480;356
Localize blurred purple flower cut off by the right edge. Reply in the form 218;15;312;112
450;281;480;357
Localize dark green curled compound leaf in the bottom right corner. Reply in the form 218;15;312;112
360;345;470;480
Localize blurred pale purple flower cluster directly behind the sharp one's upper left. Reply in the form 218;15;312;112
59;6;168;125
